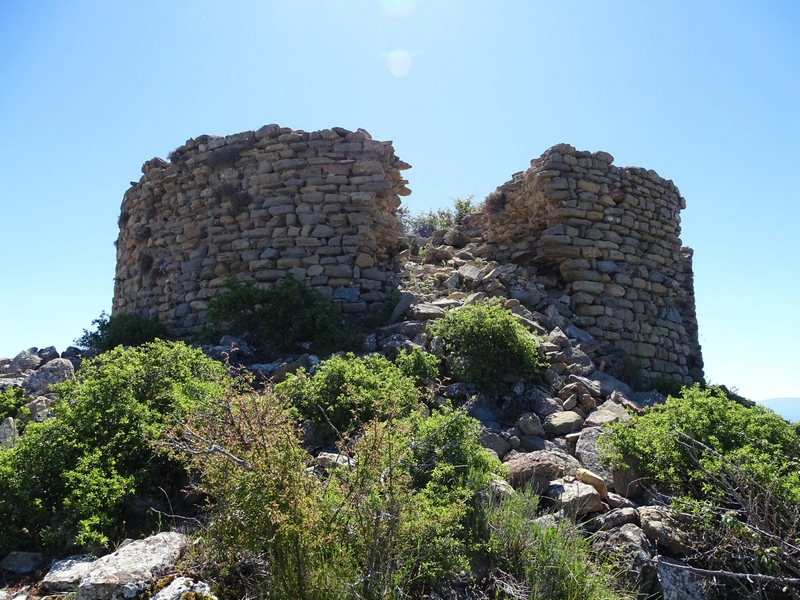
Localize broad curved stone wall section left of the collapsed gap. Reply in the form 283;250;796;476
113;125;410;335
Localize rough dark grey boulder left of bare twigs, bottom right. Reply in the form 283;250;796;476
591;523;658;597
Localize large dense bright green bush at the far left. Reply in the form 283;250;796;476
0;341;230;553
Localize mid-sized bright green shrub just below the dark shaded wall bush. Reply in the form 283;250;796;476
275;353;417;439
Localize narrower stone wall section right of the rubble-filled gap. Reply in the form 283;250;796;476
484;144;702;383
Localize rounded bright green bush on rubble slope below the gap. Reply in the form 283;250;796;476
430;302;547;385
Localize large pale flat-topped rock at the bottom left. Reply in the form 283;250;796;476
76;532;186;600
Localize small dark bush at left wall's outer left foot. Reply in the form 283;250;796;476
75;311;170;352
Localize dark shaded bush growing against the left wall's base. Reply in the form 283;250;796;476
203;275;339;351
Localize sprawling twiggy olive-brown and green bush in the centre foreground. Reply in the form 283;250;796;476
175;393;500;600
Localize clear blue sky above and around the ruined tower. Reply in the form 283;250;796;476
0;0;800;399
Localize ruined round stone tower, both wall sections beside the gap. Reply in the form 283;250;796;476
112;125;703;383
